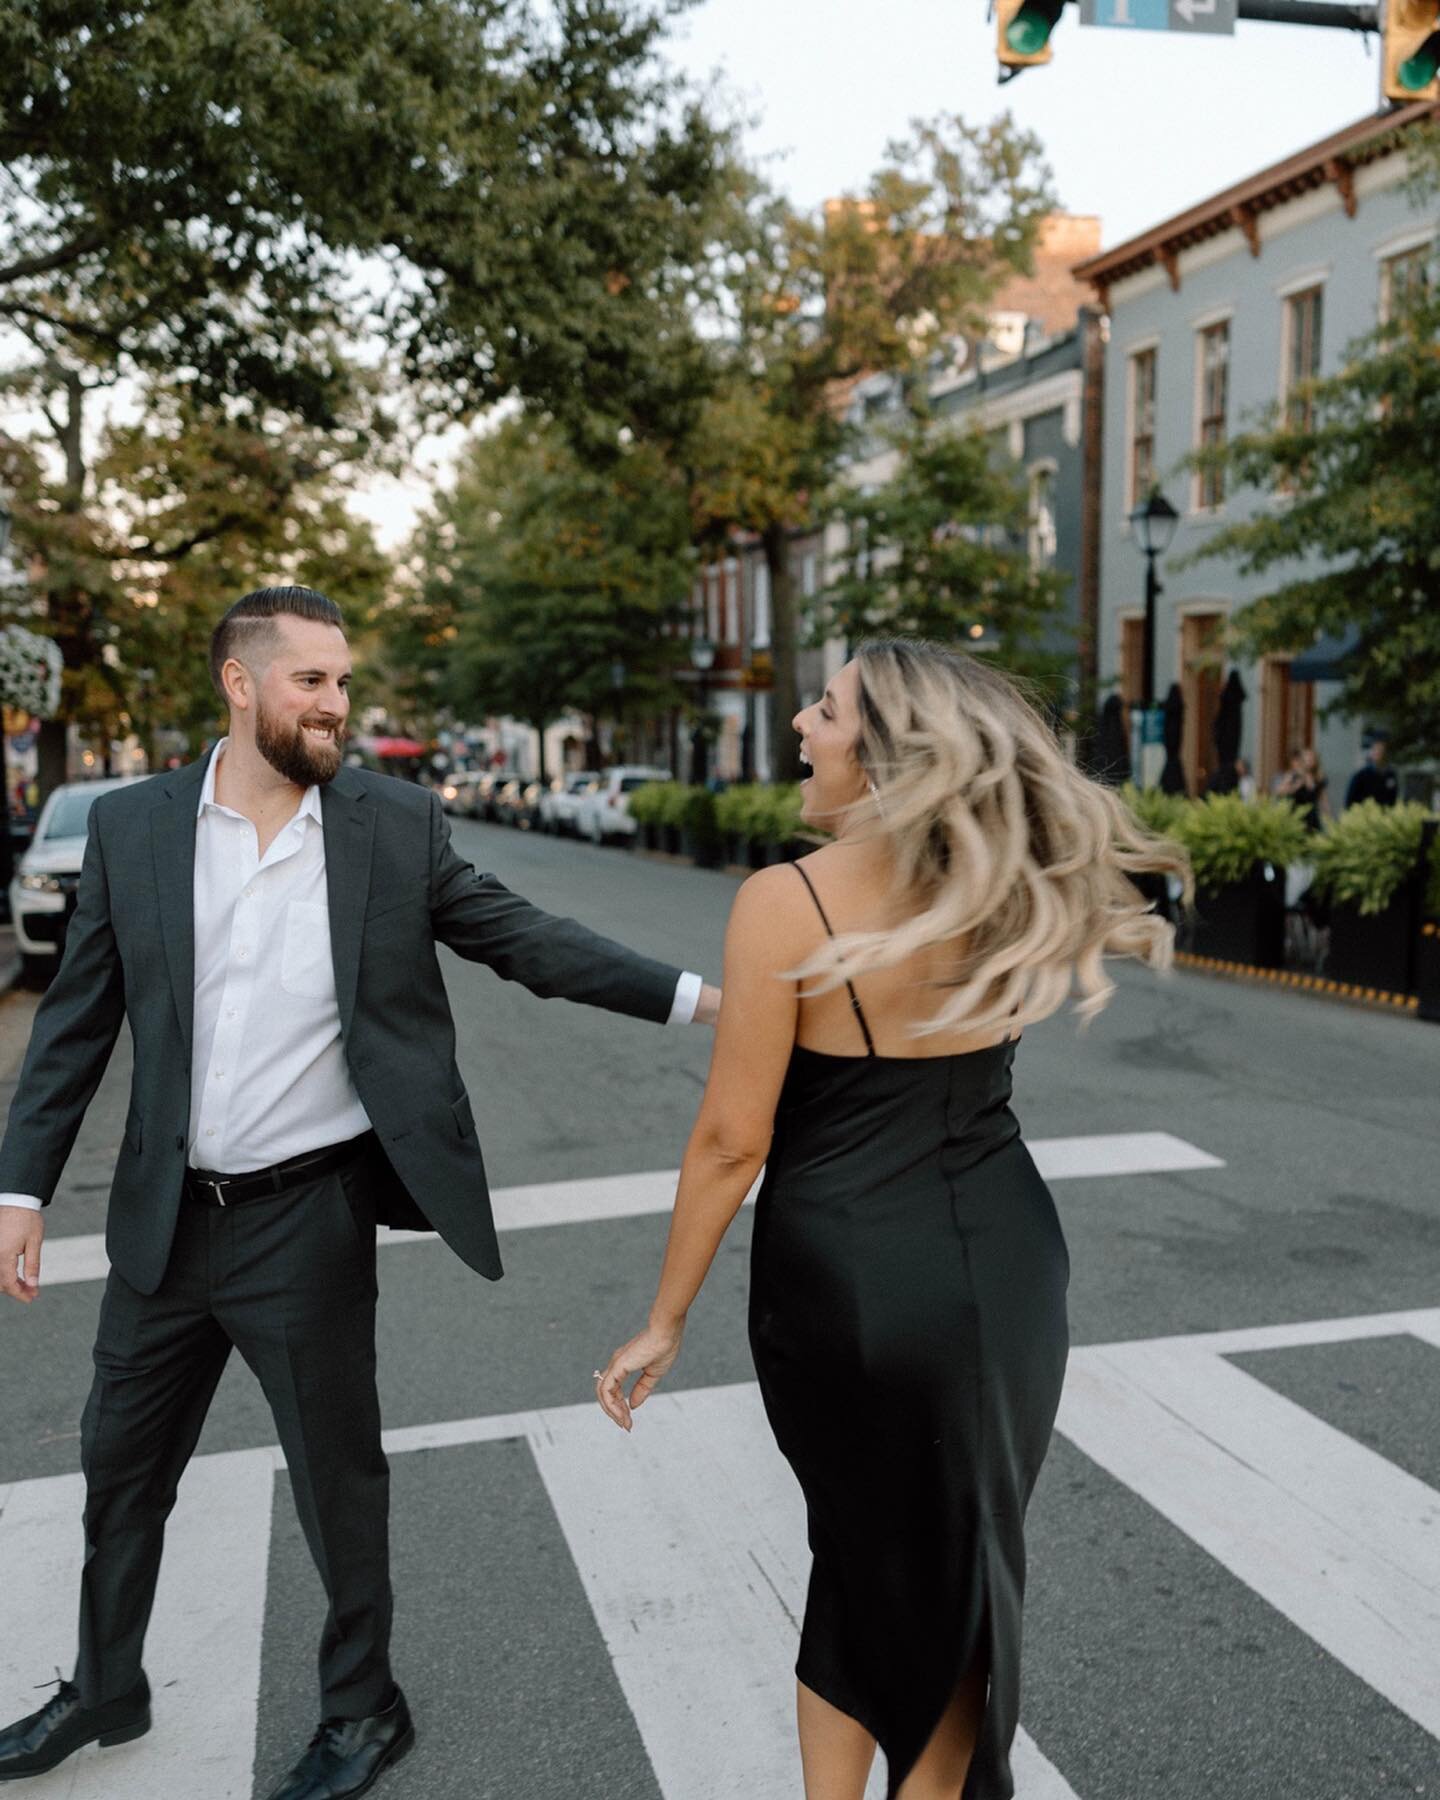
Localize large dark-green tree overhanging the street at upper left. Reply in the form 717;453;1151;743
0;0;722;779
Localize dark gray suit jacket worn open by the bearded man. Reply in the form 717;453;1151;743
0;760;680;1294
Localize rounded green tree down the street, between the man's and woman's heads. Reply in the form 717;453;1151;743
399;414;693;776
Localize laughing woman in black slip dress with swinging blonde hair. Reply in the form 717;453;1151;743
599;641;1186;1800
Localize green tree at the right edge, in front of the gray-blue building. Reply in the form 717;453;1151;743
1192;195;1440;758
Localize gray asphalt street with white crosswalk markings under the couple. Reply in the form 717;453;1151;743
0;823;1440;1800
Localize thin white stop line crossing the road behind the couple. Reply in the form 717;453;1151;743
41;1130;1224;1287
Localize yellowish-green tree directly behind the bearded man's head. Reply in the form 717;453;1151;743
0;383;392;751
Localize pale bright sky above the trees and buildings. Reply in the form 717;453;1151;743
353;0;1379;545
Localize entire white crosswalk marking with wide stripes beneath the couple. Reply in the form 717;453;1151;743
19;1309;1440;1800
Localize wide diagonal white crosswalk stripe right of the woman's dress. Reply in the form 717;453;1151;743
1058;1343;1440;1737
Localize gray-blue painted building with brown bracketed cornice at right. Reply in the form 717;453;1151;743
1076;106;1436;806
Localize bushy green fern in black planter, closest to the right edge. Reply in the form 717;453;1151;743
1310;799;1431;994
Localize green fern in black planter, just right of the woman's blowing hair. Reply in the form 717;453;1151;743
1172;794;1310;968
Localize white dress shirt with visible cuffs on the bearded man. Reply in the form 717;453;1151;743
0;738;700;1208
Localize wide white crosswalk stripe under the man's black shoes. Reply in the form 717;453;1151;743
0;1449;277;1800
